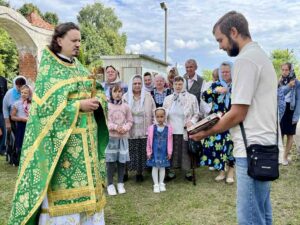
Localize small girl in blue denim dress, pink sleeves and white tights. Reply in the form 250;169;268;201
147;107;173;193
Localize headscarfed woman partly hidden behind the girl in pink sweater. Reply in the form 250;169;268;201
102;65;128;100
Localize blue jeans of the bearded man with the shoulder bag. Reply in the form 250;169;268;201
235;158;272;225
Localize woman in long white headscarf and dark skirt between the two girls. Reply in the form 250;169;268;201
123;75;155;182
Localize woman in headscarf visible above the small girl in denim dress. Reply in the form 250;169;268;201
151;74;171;107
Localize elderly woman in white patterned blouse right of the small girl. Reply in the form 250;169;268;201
163;76;199;181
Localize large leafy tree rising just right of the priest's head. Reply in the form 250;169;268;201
77;3;127;66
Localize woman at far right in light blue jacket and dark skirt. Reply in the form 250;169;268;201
278;63;300;165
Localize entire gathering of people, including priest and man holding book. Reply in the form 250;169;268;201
0;12;300;224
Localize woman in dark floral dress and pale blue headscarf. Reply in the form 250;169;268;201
200;62;235;184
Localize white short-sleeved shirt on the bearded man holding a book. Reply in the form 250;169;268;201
230;42;277;157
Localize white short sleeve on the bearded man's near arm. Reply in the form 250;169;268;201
231;59;259;105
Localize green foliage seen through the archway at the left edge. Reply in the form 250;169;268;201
0;28;18;81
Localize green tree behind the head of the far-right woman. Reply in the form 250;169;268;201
271;49;300;77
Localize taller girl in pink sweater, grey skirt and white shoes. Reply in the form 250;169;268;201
105;84;133;195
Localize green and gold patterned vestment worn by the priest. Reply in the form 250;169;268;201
9;48;108;225
